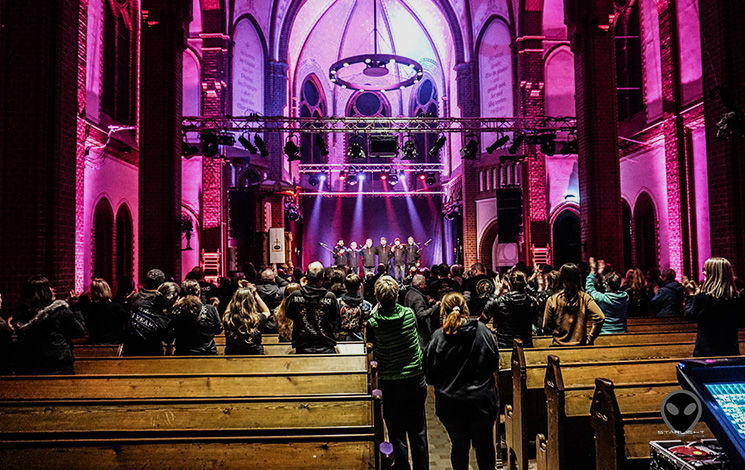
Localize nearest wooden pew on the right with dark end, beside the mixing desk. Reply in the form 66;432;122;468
590;378;713;470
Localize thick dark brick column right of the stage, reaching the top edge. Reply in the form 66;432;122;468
564;0;623;266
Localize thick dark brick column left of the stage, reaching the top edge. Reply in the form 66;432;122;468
139;0;191;278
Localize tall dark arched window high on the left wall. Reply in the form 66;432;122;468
101;0;133;124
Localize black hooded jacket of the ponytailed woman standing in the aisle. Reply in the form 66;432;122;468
424;319;499;418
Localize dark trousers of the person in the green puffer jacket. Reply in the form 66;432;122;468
378;375;429;470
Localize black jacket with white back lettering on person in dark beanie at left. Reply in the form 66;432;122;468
123;289;173;356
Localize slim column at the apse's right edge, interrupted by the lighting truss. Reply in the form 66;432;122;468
455;62;479;266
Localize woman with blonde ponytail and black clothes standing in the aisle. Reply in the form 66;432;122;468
424;292;499;470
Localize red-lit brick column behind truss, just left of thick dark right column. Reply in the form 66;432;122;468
516;10;550;262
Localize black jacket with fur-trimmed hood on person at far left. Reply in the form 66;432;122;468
12;300;85;375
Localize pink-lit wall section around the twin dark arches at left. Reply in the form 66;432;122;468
83;154;139;290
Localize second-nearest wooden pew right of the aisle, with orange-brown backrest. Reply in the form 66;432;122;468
536;355;708;470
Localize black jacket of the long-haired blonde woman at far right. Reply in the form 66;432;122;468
685;292;745;357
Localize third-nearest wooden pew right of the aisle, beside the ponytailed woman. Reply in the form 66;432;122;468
500;340;745;470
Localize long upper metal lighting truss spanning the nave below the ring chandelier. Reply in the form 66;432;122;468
182;116;577;134
